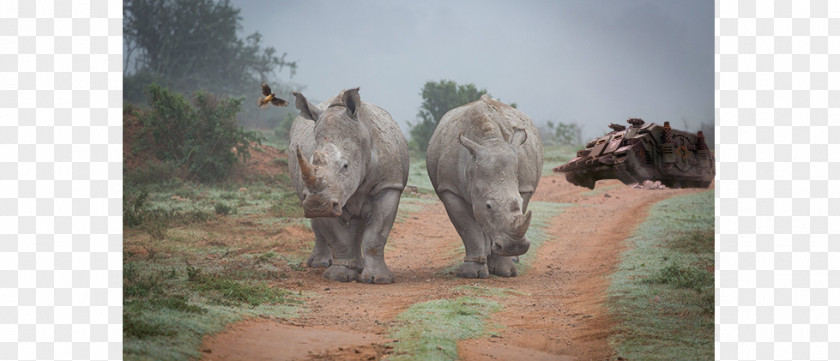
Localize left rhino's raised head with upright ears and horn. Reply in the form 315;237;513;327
294;88;370;218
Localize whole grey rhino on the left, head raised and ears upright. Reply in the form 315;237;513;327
289;88;408;283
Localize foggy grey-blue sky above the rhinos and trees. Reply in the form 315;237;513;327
232;0;714;140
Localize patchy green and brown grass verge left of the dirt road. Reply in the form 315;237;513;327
123;173;312;360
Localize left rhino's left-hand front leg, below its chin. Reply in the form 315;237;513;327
312;218;361;282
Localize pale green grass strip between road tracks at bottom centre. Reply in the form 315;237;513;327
390;296;502;361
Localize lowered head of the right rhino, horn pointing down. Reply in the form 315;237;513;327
458;129;531;256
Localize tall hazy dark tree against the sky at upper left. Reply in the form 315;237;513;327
123;0;297;107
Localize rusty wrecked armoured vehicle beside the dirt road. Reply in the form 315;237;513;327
554;118;715;189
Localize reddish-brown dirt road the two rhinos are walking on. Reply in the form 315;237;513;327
202;175;700;360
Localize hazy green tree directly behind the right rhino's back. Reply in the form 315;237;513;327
409;80;487;152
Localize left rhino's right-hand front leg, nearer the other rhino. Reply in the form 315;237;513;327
359;189;402;283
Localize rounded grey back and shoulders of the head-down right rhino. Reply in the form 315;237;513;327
426;96;543;199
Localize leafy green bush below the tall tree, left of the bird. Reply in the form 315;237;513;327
141;84;262;182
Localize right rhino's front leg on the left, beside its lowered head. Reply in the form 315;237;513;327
440;192;490;278
